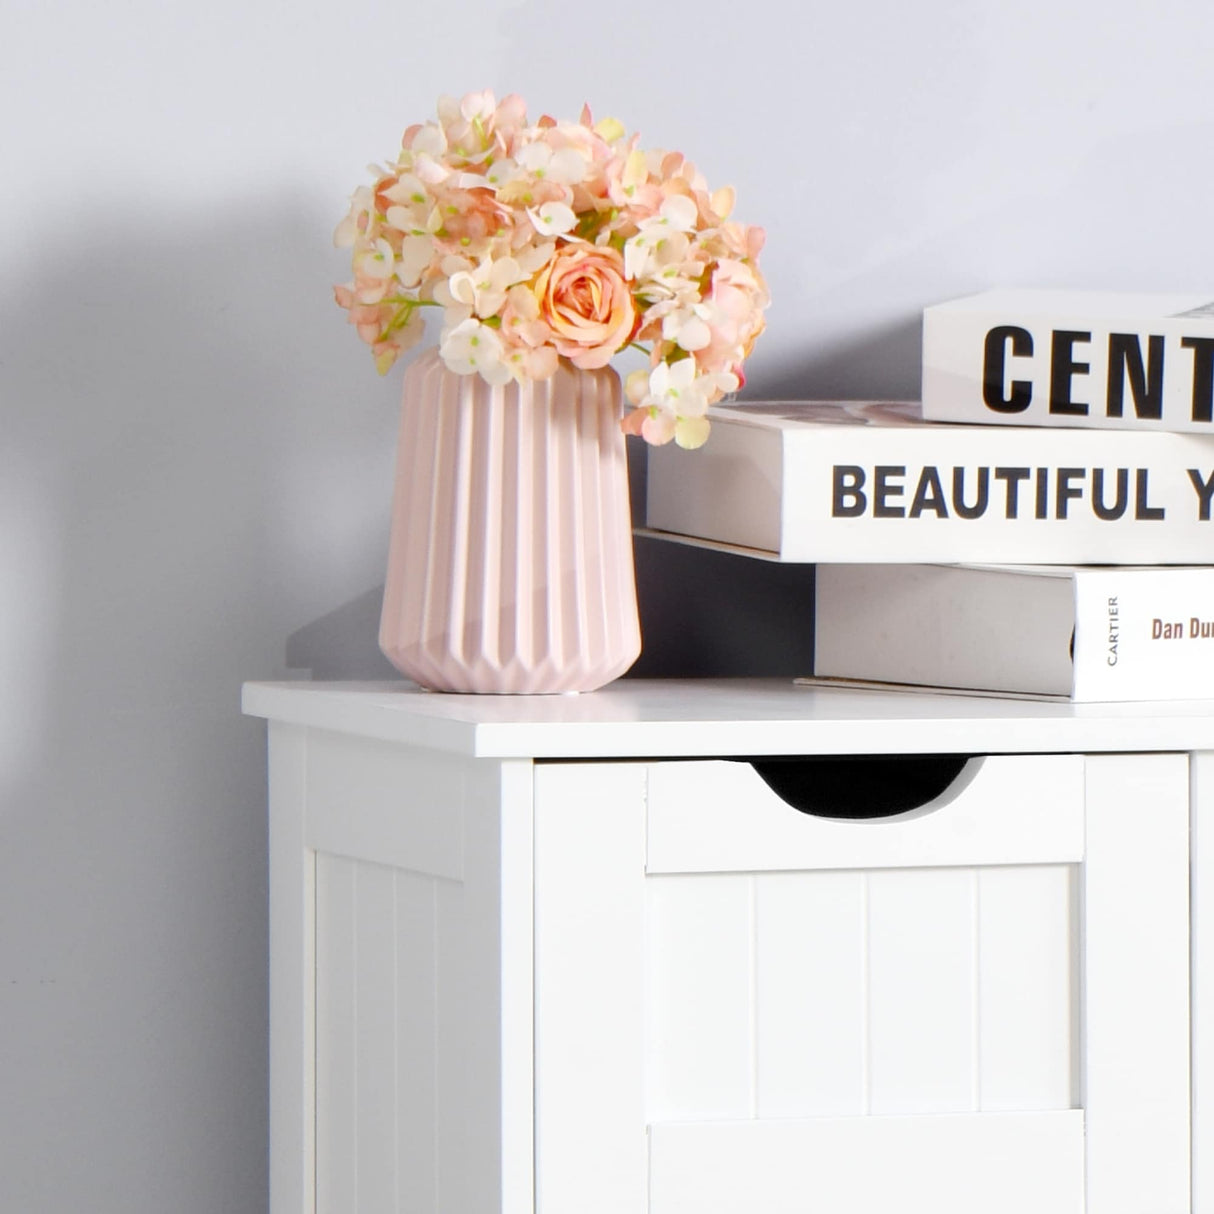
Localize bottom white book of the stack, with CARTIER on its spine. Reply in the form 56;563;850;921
813;565;1214;702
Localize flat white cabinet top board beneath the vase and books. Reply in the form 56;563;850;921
243;679;1214;759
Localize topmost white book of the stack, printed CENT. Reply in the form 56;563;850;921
923;290;1214;433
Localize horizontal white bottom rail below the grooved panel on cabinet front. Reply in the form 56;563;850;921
648;1111;1087;1214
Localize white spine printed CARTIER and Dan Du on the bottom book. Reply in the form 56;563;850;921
1073;568;1214;702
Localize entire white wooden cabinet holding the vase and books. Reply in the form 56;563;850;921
245;681;1214;1214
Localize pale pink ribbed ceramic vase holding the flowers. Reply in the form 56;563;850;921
380;350;641;693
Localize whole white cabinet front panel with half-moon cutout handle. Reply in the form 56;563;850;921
535;755;1189;1214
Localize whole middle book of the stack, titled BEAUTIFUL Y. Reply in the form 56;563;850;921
646;402;1214;565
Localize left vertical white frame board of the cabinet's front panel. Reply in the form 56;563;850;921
535;764;648;1214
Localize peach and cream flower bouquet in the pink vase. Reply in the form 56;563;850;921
335;92;768;447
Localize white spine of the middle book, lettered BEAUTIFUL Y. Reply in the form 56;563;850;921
776;426;1214;565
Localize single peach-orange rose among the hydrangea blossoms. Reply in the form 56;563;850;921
535;244;636;370
